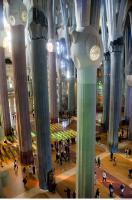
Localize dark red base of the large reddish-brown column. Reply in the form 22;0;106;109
20;151;34;165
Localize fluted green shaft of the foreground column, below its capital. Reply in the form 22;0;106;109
77;67;96;198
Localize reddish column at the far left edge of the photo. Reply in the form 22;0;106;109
0;1;11;136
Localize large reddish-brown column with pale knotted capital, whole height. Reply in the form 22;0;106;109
5;0;33;164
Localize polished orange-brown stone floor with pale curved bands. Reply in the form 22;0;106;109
0;116;132;198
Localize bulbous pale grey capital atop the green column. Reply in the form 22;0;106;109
71;26;102;69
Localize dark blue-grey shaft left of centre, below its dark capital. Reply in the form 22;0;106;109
32;38;52;189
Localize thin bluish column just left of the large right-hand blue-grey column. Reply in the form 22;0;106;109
103;52;110;130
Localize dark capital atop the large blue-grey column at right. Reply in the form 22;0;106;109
110;37;124;52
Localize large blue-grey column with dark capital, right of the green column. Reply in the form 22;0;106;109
108;38;123;152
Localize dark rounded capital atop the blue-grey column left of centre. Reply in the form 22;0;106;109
28;7;48;40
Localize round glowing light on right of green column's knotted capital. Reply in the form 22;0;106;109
90;45;101;61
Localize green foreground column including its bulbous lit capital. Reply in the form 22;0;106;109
71;26;101;198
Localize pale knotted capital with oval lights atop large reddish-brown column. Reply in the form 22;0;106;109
5;0;27;26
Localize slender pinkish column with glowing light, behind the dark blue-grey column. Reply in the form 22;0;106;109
48;0;58;123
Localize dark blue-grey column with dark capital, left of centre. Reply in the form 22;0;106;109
29;7;52;189
